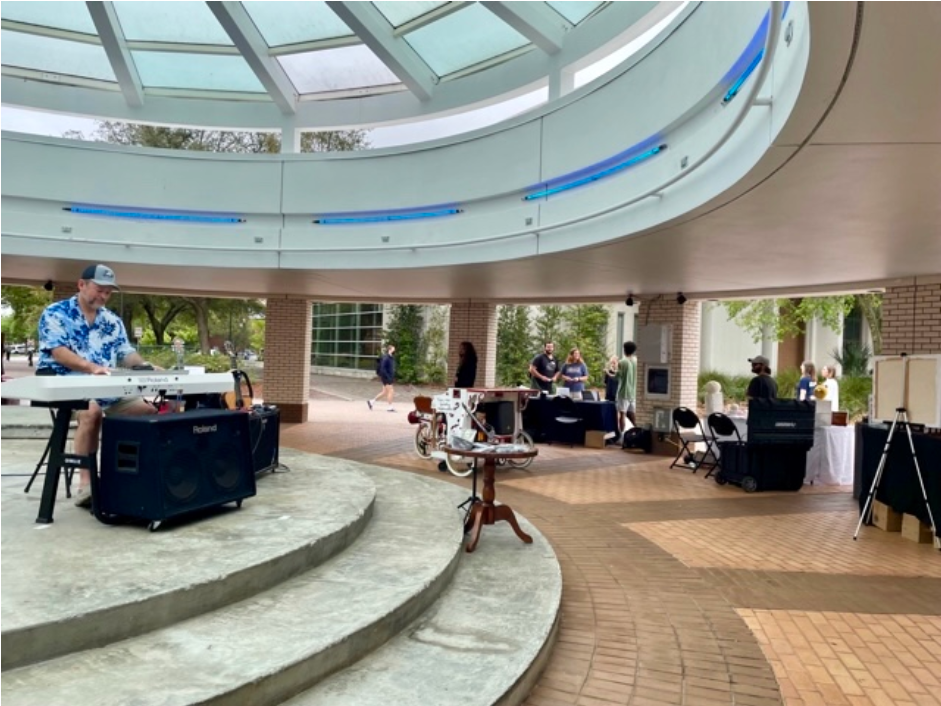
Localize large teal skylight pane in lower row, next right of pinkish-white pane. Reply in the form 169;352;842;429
405;3;529;76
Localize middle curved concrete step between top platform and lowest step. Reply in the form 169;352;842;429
0;457;466;706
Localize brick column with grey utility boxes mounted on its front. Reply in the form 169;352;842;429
637;295;702;426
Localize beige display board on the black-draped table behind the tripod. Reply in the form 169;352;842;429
872;354;941;429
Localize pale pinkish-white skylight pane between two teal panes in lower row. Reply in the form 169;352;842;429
278;45;399;93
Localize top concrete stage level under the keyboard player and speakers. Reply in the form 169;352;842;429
0;448;376;668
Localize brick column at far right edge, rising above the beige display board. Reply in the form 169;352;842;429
882;275;941;355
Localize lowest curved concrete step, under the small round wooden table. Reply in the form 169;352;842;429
286;508;562;706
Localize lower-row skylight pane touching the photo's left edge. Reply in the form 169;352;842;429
0;30;117;81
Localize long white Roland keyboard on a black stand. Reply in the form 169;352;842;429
0;370;234;402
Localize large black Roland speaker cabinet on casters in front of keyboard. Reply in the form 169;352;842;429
99;409;255;523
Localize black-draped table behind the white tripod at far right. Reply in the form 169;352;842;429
854;424;941;536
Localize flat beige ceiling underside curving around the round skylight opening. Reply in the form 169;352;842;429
2;2;941;302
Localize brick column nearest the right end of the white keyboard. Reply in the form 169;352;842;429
264;298;311;424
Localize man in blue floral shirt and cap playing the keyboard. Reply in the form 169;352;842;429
36;265;157;507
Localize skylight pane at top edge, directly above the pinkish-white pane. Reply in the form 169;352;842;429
242;0;353;47
